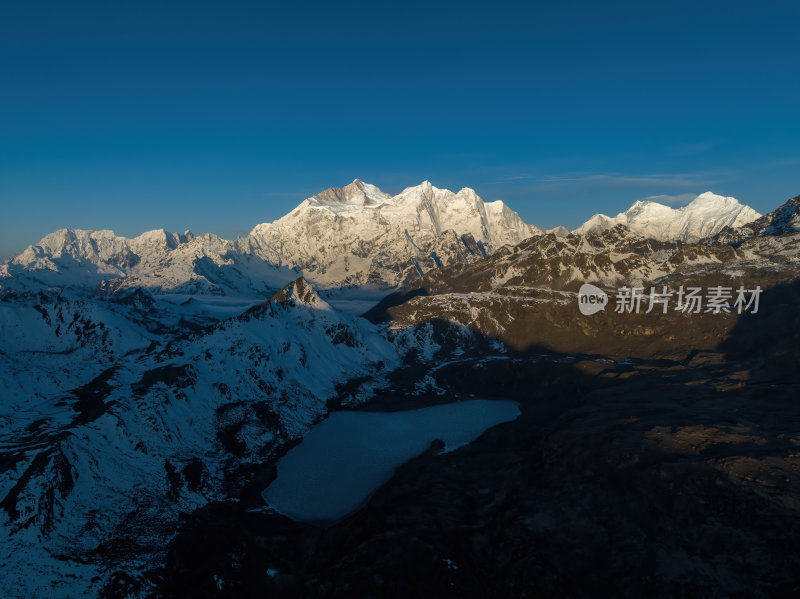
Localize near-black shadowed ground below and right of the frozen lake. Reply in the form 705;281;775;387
144;282;800;598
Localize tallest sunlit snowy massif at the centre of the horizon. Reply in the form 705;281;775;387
247;179;540;286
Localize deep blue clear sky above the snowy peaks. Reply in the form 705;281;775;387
0;0;800;259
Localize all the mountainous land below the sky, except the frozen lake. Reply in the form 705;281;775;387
0;180;800;597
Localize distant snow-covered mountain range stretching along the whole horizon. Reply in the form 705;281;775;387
0;179;761;297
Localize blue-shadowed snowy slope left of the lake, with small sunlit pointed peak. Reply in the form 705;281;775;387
0;279;398;597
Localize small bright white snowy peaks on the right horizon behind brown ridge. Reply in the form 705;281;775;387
573;191;761;242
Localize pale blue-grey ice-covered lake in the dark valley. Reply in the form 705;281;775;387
263;399;520;522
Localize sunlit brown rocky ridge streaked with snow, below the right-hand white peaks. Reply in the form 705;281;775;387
366;200;800;357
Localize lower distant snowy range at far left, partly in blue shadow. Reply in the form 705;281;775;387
0;229;299;297
